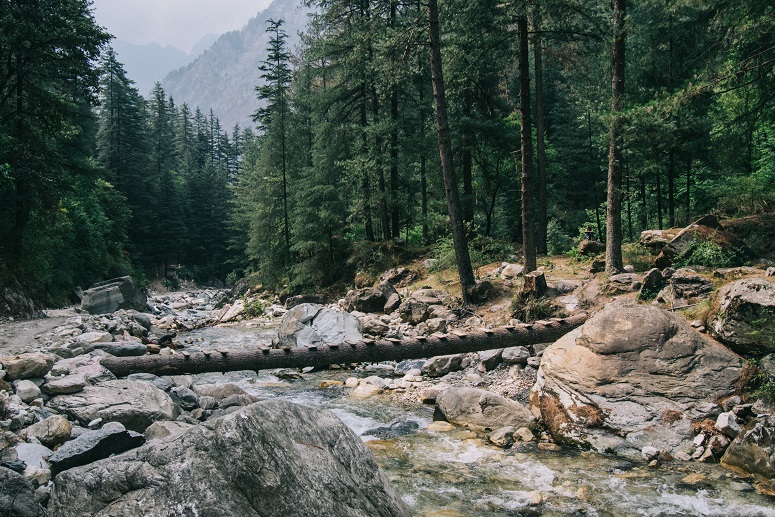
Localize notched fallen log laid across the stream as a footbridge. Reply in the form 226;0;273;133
101;314;587;377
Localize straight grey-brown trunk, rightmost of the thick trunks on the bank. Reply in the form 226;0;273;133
605;0;626;276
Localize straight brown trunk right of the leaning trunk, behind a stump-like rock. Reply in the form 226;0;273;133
517;15;536;273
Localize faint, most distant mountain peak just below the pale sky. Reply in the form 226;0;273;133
111;34;218;96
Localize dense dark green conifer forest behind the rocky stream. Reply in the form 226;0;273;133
0;0;775;303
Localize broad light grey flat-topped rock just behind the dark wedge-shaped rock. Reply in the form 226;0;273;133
49;380;179;433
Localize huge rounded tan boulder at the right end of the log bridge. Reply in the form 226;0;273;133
530;300;742;459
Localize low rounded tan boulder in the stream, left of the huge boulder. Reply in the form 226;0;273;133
436;388;534;431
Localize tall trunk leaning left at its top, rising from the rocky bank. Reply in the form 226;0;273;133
428;0;476;304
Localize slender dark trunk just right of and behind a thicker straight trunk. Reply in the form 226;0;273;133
533;4;549;255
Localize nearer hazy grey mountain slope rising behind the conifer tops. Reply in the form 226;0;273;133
162;0;308;130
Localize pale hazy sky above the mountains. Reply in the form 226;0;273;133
92;0;271;52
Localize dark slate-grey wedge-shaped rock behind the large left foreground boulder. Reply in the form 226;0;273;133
48;429;145;475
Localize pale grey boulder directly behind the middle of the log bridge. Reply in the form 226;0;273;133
277;303;363;347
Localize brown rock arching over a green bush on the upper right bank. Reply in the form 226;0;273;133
654;215;753;269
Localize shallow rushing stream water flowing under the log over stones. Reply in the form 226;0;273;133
181;326;775;517
